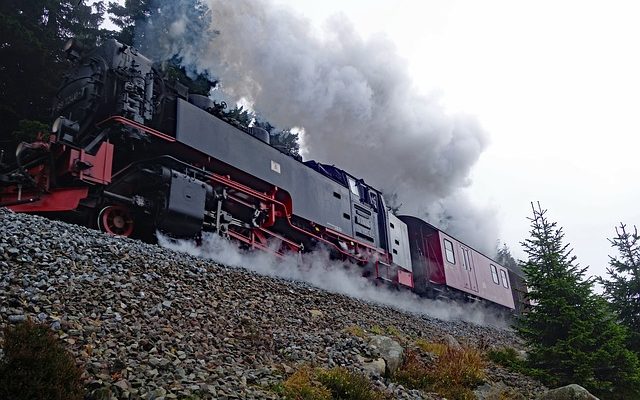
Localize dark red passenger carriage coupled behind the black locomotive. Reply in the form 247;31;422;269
399;216;516;310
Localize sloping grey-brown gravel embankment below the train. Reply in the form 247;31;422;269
0;209;542;399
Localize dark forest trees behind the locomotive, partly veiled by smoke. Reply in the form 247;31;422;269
0;0;299;156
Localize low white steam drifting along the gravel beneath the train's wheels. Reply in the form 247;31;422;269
157;233;507;328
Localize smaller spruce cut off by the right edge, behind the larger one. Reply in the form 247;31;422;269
600;223;640;354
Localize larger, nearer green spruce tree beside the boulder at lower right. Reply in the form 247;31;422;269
517;204;640;399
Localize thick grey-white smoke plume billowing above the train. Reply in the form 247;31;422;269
137;0;497;252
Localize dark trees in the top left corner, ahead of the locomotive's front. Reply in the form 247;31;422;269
0;0;107;143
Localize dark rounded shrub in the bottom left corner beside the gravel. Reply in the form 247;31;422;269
0;321;84;400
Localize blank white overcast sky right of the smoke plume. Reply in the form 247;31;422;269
270;0;640;275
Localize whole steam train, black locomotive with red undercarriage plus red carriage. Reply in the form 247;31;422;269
0;39;525;311
